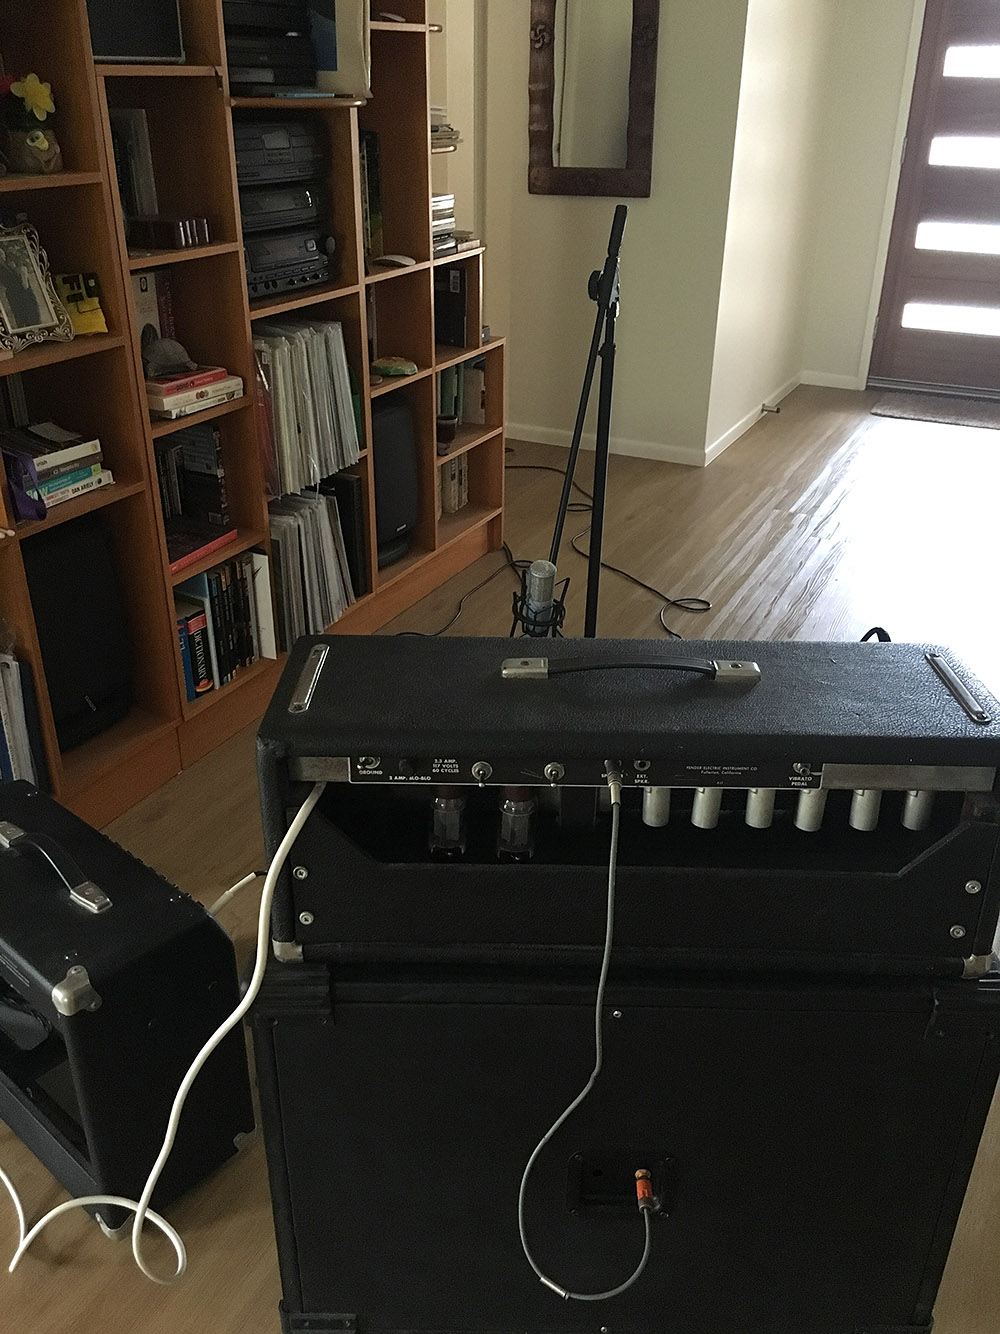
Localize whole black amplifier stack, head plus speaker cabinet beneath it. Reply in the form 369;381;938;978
252;636;1000;1334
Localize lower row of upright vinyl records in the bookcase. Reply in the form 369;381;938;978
268;491;355;650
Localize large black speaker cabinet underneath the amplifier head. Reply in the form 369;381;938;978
252;965;1000;1334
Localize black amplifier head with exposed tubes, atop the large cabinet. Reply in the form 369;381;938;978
259;634;1000;975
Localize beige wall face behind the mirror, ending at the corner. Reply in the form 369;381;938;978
485;0;747;463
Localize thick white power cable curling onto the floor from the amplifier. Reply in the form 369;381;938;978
0;783;327;1286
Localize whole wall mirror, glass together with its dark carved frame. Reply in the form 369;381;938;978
528;0;660;199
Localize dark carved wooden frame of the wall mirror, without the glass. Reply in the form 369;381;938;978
528;0;660;199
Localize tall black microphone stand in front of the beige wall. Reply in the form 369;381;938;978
549;204;628;639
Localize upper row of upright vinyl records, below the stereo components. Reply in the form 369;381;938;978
253;320;361;495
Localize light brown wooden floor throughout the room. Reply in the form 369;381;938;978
0;387;1000;1334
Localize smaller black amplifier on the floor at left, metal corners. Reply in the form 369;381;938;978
0;782;253;1229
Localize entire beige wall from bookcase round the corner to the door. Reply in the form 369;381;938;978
482;0;923;464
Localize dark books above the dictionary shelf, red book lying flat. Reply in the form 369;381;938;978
156;422;237;574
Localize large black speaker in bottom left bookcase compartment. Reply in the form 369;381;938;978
21;514;132;751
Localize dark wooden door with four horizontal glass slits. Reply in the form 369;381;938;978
869;0;1000;394
